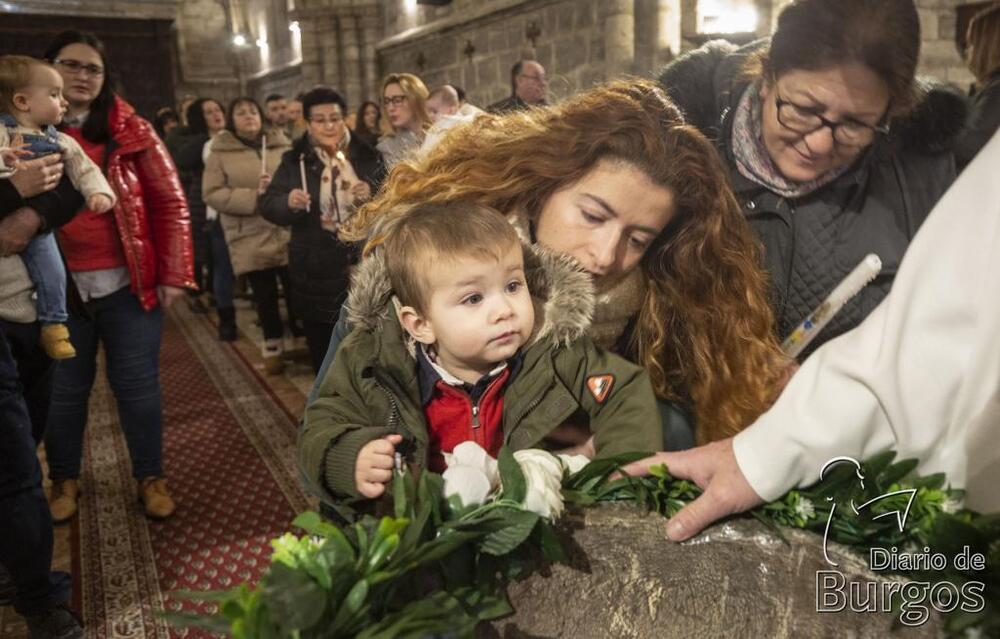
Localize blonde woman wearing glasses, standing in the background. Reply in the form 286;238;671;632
375;73;431;169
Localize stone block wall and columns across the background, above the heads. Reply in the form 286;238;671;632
377;0;971;111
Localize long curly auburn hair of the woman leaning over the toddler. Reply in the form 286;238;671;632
342;79;789;442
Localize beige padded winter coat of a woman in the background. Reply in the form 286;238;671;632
202;131;291;275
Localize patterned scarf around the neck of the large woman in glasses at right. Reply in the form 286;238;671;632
733;82;850;198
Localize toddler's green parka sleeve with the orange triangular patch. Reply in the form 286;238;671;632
556;337;663;457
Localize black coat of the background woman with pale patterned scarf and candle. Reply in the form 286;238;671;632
257;135;385;324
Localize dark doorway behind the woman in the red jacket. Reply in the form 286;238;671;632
0;13;174;119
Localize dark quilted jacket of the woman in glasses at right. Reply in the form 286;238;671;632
659;41;966;357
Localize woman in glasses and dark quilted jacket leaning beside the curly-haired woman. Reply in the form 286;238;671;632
660;0;965;355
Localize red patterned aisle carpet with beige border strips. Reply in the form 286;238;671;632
74;305;309;639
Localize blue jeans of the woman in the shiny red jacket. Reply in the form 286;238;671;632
45;288;163;481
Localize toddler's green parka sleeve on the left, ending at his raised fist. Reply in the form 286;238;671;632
298;331;395;502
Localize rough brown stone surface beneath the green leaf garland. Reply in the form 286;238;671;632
492;506;941;639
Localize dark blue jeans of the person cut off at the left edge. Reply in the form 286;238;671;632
0;322;71;615
